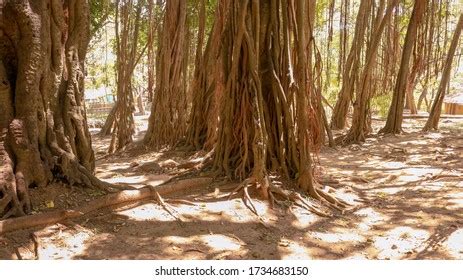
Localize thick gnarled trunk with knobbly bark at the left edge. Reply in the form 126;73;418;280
0;0;101;219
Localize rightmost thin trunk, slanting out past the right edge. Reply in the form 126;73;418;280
423;13;463;131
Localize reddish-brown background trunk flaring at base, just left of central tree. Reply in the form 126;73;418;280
144;0;187;149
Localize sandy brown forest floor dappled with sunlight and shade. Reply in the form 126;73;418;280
0;115;463;259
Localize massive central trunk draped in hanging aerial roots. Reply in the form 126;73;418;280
213;0;346;210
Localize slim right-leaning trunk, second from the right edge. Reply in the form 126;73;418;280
380;0;426;134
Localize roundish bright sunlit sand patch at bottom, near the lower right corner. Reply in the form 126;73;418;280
374;227;429;259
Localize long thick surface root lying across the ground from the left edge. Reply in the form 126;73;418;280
0;178;212;234
